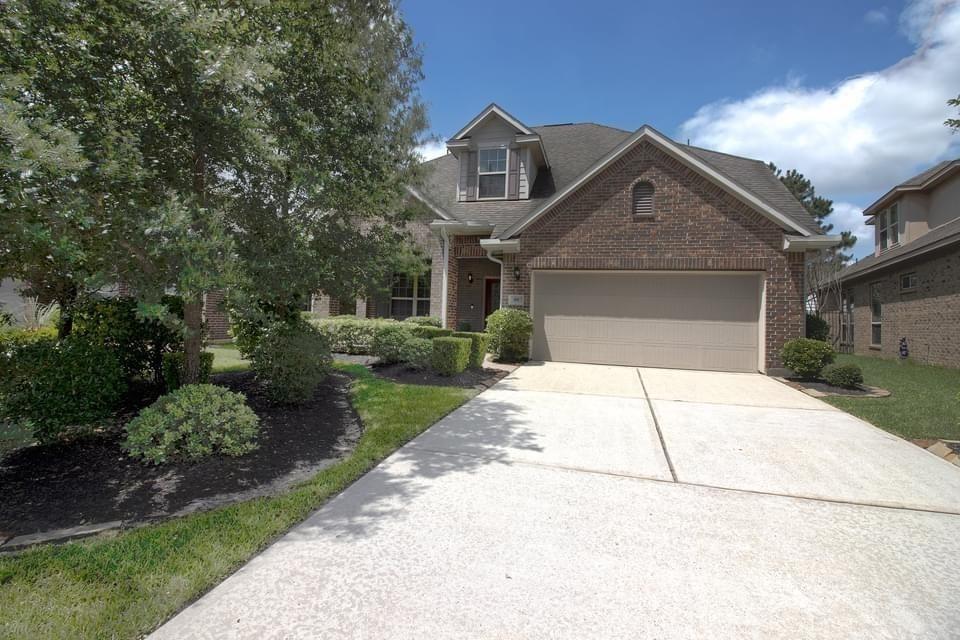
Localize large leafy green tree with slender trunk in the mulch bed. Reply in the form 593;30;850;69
0;0;424;381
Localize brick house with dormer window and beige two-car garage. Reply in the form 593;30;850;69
315;104;838;371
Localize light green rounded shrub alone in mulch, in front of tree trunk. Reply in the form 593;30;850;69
123;384;260;464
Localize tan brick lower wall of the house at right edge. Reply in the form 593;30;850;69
845;247;960;367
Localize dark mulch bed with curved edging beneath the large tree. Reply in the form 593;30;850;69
0;371;361;535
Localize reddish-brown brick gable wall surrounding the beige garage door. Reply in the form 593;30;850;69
488;143;804;367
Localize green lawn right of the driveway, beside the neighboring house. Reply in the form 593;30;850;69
824;354;960;440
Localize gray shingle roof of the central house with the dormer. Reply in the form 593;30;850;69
421;123;820;237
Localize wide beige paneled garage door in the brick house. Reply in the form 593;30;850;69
533;271;760;371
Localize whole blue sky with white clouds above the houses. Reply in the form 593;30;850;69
401;0;960;255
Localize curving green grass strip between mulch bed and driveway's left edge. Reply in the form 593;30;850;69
0;365;473;638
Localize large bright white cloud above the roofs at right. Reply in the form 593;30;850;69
680;0;960;200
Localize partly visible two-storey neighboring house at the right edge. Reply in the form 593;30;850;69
830;159;960;367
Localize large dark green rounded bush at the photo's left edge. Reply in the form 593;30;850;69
0;336;127;442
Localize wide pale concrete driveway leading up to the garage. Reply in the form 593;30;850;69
155;363;960;639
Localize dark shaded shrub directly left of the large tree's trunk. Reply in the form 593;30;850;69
73;296;183;382
